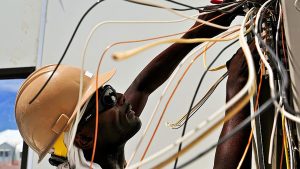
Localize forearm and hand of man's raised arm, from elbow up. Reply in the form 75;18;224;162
132;13;234;93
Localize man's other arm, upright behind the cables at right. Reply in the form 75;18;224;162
214;41;257;169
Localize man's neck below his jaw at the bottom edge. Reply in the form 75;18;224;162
83;146;126;169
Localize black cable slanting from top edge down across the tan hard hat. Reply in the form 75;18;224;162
29;0;104;104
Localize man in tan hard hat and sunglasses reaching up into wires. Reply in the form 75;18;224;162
16;5;248;169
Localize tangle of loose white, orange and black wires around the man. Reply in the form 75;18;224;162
27;0;300;168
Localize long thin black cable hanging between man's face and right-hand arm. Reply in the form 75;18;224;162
174;40;238;168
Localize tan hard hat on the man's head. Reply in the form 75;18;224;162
15;65;115;162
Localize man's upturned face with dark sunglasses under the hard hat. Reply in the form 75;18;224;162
79;87;141;148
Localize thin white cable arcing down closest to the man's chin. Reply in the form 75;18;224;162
127;29;235;166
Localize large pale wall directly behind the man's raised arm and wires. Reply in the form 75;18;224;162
14;0;243;169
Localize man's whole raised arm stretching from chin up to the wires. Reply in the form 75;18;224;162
125;12;235;115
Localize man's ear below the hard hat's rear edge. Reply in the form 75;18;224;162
74;128;94;150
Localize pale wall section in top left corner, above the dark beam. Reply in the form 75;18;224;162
0;0;41;68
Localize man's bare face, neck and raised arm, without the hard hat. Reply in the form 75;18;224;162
74;9;241;169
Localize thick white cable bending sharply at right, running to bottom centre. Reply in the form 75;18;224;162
128;9;256;169
